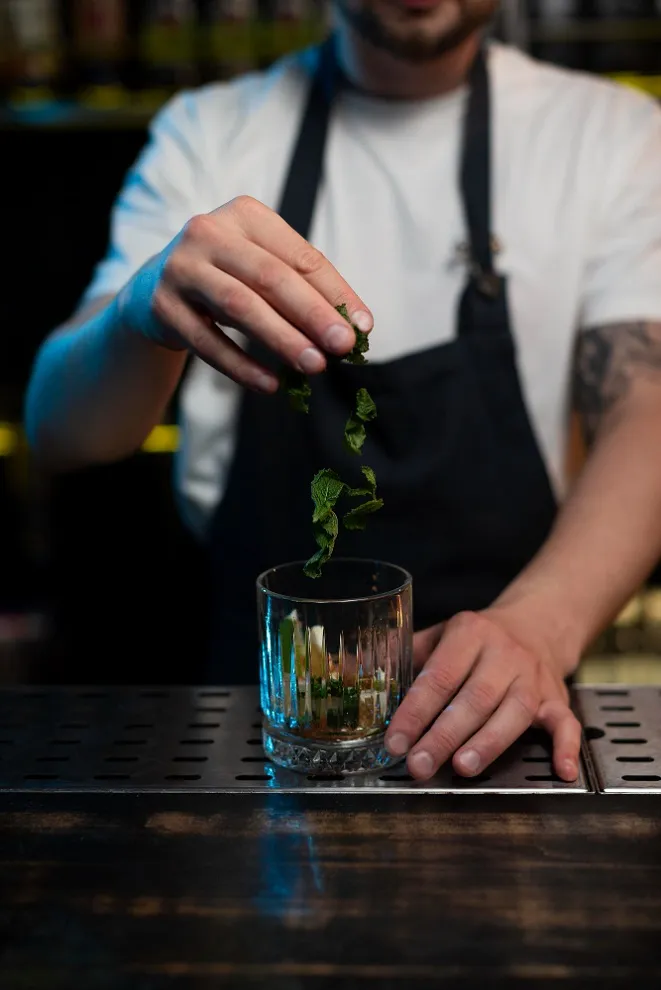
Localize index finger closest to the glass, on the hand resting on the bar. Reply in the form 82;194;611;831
385;612;484;756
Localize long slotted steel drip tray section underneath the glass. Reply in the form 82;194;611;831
0;687;590;794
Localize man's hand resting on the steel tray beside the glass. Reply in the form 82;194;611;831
386;607;581;781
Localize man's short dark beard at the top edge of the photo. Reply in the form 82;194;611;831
334;0;498;62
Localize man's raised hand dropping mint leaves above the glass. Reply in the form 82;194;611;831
116;196;373;393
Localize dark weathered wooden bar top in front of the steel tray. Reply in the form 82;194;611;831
0;793;661;990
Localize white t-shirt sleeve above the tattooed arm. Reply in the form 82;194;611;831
580;92;661;328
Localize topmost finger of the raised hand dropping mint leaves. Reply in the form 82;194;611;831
221;196;374;333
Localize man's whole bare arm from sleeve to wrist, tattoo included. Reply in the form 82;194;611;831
497;321;661;672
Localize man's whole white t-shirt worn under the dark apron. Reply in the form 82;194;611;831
86;44;661;533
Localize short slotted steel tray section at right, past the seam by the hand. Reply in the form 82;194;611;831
575;684;661;794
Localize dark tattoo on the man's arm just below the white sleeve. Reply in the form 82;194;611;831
573;320;661;443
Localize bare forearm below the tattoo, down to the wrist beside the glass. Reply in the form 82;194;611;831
497;403;661;673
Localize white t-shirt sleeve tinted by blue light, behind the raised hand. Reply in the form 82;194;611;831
83;92;206;302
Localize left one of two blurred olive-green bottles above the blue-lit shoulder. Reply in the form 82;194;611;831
139;0;199;107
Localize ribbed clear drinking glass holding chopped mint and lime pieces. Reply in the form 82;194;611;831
257;558;413;773
